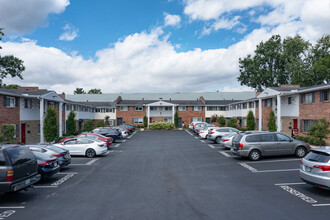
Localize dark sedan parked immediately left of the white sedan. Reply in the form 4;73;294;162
26;145;71;168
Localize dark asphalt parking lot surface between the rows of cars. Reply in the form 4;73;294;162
0;131;330;219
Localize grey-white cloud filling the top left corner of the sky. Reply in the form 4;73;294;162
0;0;70;35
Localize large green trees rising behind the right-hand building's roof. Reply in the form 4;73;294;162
237;35;330;91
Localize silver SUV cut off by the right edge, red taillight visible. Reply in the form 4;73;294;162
299;146;330;189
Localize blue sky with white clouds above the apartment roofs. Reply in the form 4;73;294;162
0;0;330;93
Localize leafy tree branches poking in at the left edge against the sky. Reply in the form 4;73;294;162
0;28;25;87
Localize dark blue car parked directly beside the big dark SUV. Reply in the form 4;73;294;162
32;151;61;179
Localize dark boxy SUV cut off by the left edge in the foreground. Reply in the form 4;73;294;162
0;145;41;192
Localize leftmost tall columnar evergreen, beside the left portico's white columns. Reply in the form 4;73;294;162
44;106;58;142
